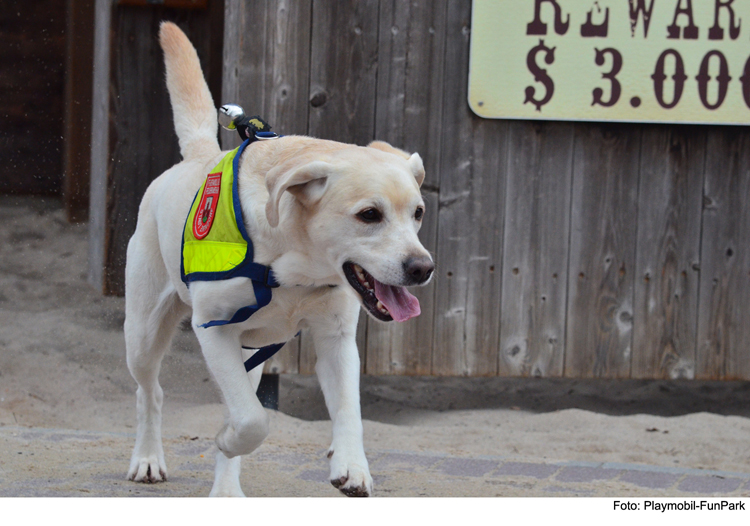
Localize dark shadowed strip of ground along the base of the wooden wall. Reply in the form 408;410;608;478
279;375;750;424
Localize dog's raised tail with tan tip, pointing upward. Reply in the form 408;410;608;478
159;22;221;160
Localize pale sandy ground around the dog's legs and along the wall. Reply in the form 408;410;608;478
0;197;750;496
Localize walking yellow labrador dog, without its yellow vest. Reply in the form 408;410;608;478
125;23;434;496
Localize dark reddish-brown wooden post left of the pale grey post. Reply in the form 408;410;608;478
63;0;94;222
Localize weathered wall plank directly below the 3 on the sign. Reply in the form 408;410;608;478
565;124;641;378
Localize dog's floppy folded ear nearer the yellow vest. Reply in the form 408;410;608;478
266;161;333;228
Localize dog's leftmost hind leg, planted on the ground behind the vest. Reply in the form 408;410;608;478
125;238;189;482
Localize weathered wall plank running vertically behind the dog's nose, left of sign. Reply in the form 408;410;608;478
366;0;447;374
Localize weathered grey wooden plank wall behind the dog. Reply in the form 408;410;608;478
83;0;750;379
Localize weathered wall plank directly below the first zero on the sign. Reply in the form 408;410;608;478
631;130;707;378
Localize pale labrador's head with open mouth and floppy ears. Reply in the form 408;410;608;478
266;142;435;321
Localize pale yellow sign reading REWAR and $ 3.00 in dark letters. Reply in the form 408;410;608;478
469;0;750;124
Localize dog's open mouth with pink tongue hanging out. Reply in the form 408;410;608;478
344;261;421;321
